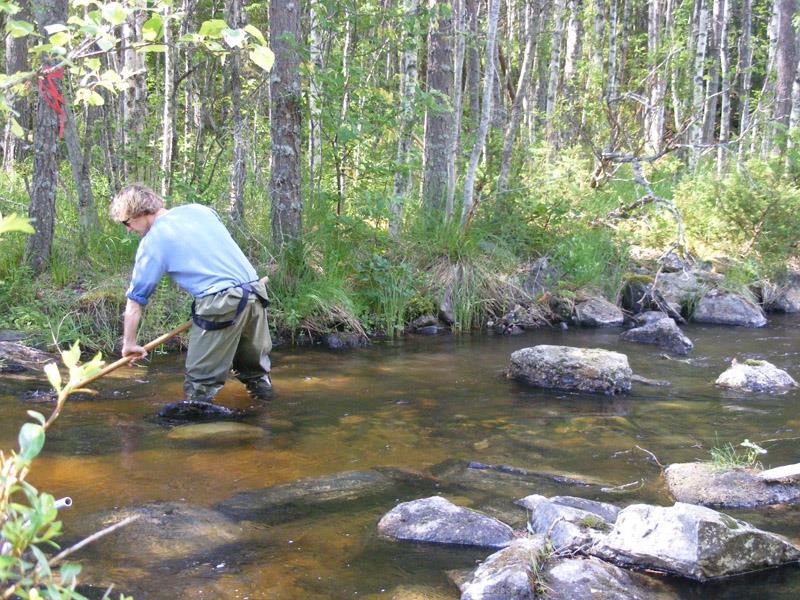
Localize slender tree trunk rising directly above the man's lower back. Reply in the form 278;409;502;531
226;0;247;225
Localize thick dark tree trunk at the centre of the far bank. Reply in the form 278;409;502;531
422;0;454;219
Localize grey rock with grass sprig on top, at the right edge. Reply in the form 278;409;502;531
664;462;800;508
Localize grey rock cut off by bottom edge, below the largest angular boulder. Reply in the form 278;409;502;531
543;557;679;600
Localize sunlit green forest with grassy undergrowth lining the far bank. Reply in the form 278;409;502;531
0;0;800;352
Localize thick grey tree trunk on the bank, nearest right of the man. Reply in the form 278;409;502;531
269;2;303;249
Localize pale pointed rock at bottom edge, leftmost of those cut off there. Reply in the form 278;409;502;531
459;535;547;600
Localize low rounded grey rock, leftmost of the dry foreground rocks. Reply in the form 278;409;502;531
378;496;514;548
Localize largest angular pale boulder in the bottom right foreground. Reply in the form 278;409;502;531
591;502;800;581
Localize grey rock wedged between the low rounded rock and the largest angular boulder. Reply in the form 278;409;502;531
516;494;619;551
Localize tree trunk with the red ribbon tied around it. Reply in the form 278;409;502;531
25;0;67;275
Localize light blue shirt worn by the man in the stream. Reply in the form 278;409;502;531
126;204;258;304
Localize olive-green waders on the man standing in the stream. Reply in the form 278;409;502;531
183;282;272;402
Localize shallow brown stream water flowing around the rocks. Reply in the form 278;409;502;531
0;317;800;598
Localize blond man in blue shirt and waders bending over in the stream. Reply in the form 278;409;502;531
109;184;272;402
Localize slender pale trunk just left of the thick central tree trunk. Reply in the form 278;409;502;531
389;0;419;240
